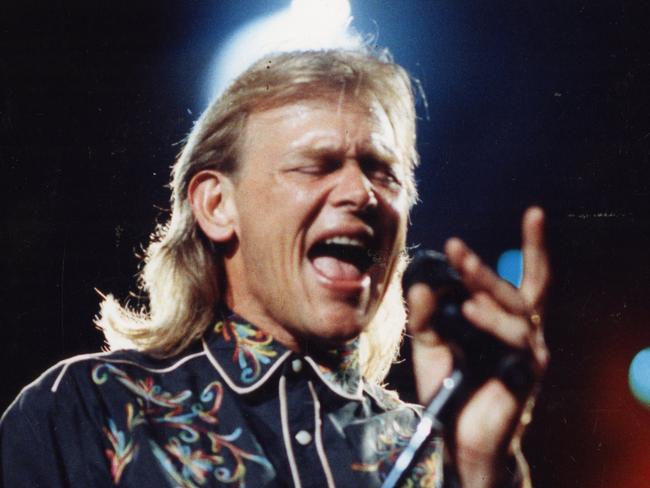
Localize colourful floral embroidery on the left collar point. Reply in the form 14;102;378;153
214;319;278;384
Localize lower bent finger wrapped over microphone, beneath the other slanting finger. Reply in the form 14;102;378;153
463;293;532;349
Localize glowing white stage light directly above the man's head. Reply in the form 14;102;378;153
208;0;360;103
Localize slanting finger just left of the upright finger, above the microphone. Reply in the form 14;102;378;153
445;238;527;314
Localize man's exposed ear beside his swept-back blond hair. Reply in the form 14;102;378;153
187;169;237;243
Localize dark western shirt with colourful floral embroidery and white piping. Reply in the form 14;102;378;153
0;316;442;488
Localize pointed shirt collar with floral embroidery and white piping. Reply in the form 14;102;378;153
203;313;363;400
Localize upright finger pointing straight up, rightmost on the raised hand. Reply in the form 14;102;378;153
521;207;550;309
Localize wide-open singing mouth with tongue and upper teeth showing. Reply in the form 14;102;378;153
307;236;375;281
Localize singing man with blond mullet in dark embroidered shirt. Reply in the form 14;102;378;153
1;46;548;487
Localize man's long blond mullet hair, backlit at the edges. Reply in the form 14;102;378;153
96;49;418;382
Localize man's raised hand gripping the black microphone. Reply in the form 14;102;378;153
407;207;550;487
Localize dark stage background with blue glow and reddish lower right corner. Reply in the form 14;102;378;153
0;0;650;488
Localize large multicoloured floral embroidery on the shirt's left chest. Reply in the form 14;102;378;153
92;363;272;488
